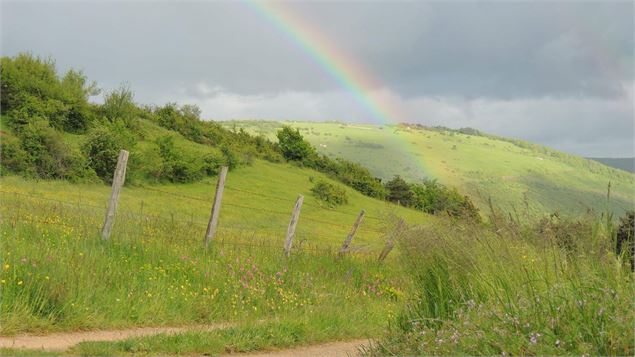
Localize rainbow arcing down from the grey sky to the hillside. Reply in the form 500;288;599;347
245;0;438;177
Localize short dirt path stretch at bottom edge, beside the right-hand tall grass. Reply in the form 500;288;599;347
224;339;368;357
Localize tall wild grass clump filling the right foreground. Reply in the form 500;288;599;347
367;211;635;355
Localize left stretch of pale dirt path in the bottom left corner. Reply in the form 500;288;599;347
0;324;229;351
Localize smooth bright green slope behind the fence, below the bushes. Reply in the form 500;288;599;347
0;161;431;249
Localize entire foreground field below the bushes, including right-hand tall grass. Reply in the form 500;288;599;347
0;162;635;355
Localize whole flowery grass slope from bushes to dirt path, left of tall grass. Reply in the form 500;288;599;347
0;161;422;336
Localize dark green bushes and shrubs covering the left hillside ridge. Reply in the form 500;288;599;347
0;54;480;215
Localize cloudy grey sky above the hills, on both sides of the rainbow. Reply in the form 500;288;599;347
0;0;635;157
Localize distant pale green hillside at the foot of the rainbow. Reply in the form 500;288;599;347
224;121;635;214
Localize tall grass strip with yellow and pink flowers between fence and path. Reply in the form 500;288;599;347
0;191;406;338
